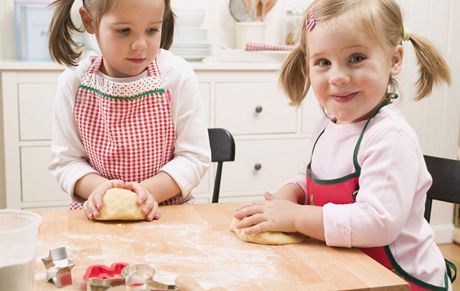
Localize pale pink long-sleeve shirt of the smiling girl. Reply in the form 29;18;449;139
288;104;452;286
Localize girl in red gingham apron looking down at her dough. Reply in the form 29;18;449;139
49;0;211;220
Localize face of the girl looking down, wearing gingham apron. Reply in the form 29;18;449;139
80;0;165;78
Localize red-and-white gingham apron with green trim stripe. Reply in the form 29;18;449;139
71;57;192;208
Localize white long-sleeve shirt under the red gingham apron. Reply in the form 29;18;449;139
49;50;211;200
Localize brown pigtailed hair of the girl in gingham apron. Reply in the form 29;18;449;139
48;0;174;66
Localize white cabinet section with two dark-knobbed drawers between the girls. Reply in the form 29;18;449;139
191;64;321;202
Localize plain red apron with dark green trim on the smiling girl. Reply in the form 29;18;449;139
306;103;448;291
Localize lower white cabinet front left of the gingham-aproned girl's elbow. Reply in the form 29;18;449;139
21;146;70;202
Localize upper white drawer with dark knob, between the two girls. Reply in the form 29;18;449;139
215;82;297;134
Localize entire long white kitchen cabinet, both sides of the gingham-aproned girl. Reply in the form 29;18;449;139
0;61;320;208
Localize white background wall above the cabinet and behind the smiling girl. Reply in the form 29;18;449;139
0;0;460;241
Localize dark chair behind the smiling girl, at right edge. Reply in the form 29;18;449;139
424;155;460;222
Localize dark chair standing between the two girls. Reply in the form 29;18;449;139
208;128;235;203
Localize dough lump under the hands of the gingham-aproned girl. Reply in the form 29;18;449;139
96;188;145;220
